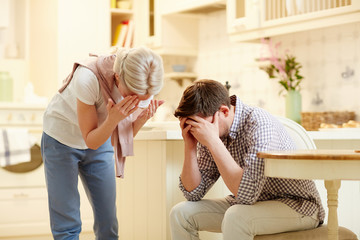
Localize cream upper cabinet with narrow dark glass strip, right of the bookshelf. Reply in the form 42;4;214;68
134;0;199;56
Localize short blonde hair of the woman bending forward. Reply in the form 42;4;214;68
113;47;164;95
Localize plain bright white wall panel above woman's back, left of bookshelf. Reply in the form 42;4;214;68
57;0;110;89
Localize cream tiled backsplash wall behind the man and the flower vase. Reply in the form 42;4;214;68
156;11;360;119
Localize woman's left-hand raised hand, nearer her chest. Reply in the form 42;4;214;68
106;95;139;125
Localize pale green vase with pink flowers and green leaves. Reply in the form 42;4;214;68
260;40;304;123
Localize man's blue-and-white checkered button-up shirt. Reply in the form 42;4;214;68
179;96;325;223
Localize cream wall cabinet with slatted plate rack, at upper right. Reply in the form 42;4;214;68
227;0;360;41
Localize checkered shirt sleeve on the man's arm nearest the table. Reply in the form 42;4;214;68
236;124;279;205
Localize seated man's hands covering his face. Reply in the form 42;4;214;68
180;111;220;148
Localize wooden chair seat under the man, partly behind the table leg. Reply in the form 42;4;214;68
254;225;358;240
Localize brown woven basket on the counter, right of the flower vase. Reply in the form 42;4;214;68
301;111;355;131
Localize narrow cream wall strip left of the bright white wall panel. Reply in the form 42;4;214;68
28;0;58;97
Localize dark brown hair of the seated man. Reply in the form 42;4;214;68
174;79;230;118
